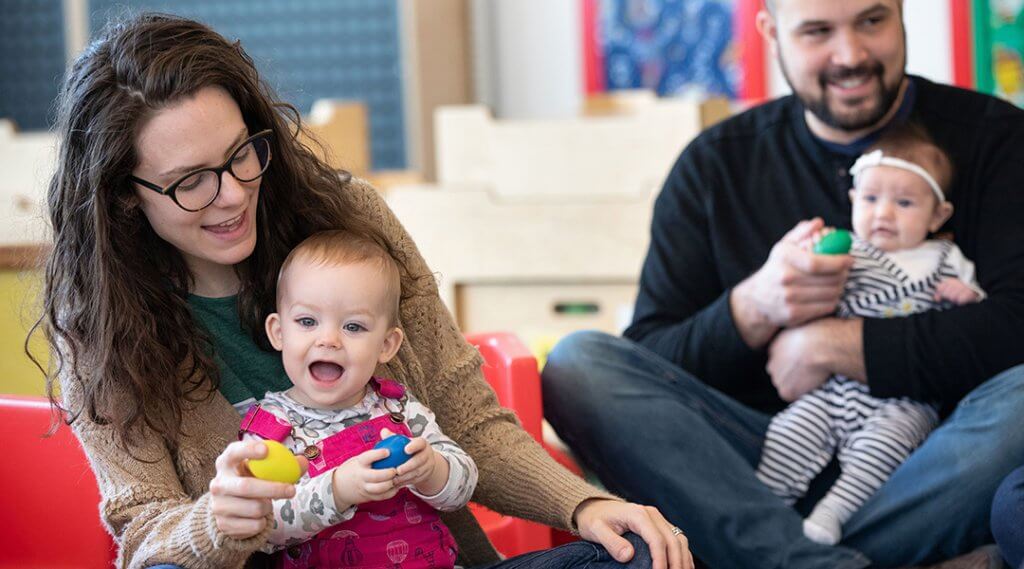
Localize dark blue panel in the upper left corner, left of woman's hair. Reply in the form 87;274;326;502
0;0;65;130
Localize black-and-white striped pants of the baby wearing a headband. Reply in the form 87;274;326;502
757;376;938;524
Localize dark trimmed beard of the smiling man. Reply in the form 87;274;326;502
778;57;903;131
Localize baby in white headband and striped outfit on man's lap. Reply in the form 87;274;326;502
758;125;985;544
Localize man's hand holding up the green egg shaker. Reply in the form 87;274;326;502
729;218;853;349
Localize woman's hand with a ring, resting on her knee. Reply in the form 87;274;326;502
573;498;693;569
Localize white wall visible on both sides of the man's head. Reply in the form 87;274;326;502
765;0;953;97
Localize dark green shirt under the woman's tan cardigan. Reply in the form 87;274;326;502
188;295;292;413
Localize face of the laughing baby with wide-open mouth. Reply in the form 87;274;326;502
266;259;402;409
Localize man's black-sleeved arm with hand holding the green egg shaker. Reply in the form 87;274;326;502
626;146;851;393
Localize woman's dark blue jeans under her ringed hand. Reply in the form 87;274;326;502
481;533;651;569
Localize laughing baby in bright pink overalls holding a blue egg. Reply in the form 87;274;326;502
242;230;477;569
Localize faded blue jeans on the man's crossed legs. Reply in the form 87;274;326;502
543;332;1024;569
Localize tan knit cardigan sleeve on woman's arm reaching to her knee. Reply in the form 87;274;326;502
350;180;620;528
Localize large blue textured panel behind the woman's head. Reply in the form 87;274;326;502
89;0;407;169
